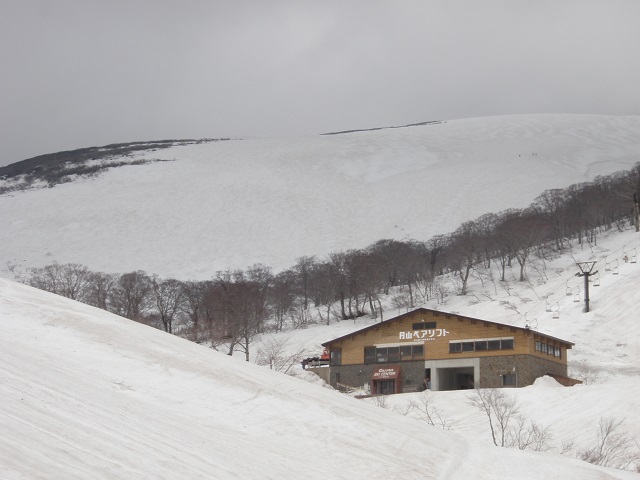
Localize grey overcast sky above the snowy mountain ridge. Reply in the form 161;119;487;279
0;0;640;165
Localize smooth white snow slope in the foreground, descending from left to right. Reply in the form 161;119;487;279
0;279;637;480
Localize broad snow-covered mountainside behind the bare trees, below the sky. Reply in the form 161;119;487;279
0;115;640;279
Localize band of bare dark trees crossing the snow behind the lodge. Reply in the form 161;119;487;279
22;163;640;360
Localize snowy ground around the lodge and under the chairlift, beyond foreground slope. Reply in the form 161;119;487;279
254;228;640;468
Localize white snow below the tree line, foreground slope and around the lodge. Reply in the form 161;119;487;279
0;222;640;480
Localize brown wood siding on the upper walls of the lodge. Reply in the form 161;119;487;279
331;312;567;365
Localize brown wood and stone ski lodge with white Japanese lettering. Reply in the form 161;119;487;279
318;308;579;395
